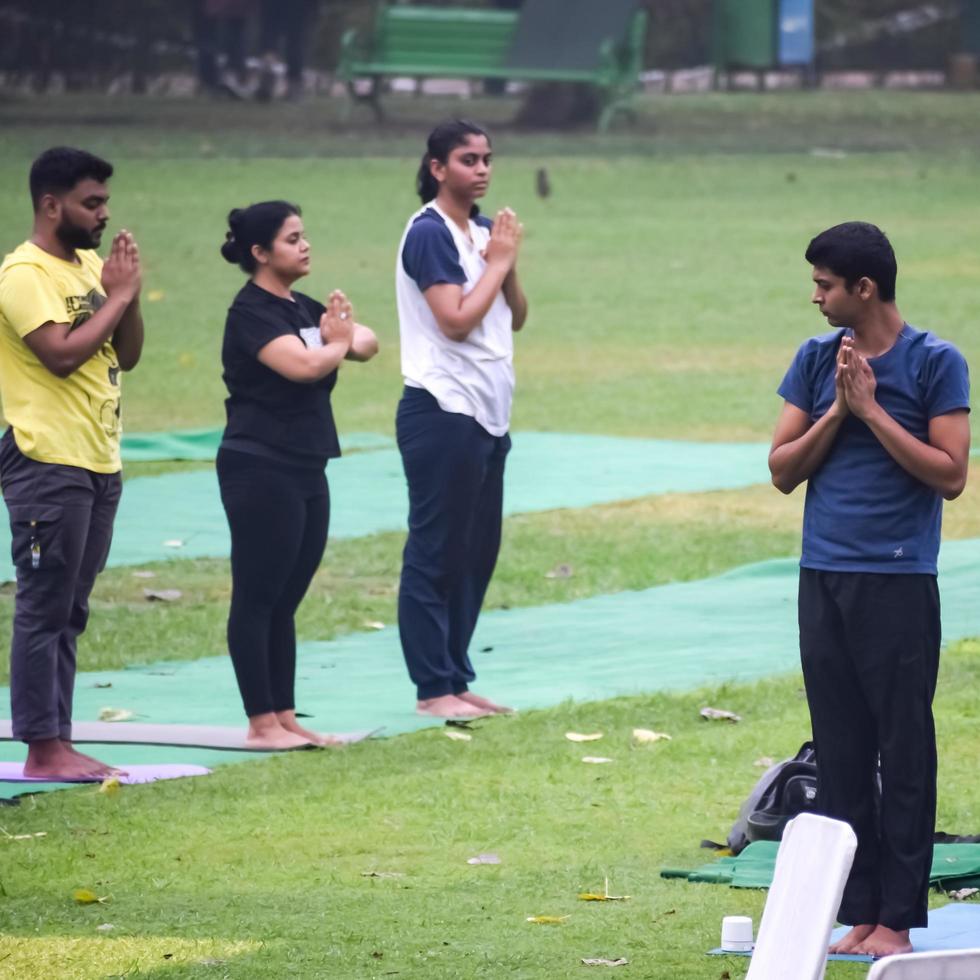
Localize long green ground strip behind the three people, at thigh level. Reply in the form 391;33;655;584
0;432;768;581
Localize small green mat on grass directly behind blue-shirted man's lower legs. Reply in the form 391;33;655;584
660;841;980;890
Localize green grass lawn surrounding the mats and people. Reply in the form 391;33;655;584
0;93;980;980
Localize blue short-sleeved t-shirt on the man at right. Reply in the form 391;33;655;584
779;324;970;575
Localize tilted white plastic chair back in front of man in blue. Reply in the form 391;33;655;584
746;813;852;980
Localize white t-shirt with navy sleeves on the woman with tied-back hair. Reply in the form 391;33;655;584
395;201;514;436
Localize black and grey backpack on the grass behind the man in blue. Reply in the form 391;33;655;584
728;742;817;854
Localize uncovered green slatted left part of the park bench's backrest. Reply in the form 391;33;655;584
374;5;517;69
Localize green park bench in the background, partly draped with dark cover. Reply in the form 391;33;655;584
337;0;647;130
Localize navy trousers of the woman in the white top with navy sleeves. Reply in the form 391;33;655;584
396;388;510;700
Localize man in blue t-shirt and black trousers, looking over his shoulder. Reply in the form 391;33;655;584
769;221;970;956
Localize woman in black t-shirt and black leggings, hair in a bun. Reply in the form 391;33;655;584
217;201;378;749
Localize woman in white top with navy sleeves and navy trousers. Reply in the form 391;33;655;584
395;120;527;717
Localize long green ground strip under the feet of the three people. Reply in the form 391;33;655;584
7;539;980;796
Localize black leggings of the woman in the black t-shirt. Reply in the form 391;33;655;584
216;449;330;718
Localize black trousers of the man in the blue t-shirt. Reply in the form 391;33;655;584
799;568;940;930
